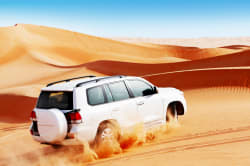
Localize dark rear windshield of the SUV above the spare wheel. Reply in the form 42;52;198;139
37;91;73;110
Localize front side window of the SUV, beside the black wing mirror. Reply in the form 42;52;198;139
127;80;153;97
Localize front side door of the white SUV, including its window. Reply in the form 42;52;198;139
126;79;163;127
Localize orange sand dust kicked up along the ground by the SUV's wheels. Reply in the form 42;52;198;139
0;121;179;166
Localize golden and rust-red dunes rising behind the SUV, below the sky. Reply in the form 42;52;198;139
0;24;250;120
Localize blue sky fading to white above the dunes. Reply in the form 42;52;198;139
0;0;250;38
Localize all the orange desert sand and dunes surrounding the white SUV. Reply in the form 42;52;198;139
0;24;250;166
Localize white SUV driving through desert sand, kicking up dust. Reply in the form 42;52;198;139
30;76;186;144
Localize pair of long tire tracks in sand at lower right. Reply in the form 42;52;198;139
88;126;250;166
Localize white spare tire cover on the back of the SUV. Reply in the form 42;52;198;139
37;109;68;143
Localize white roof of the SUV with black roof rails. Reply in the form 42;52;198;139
42;76;139;91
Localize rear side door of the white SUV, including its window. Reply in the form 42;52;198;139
105;81;143;128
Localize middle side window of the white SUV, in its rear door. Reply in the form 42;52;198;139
109;81;129;101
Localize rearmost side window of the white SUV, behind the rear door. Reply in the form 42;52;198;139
87;86;105;105
